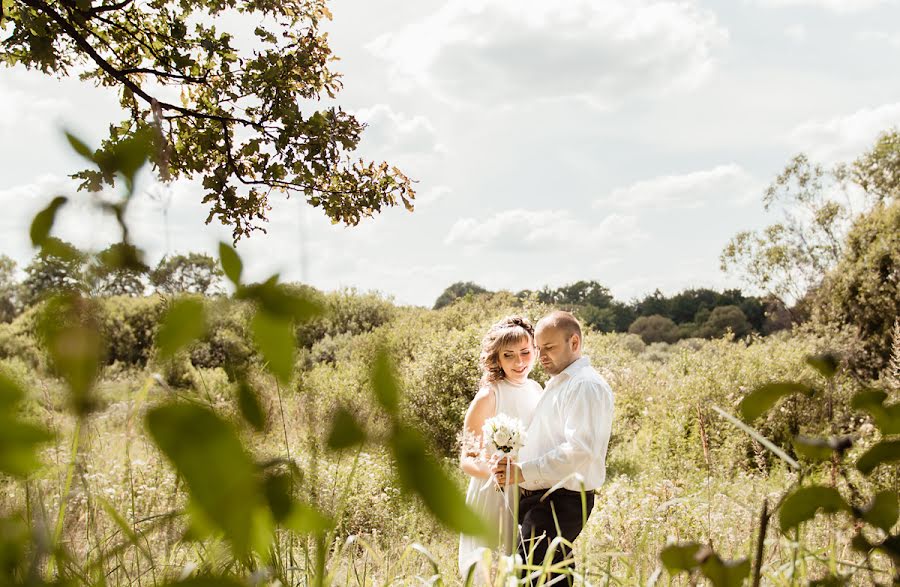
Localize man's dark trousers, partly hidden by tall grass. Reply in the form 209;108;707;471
519;489;594;585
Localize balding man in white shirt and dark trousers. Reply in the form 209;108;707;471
493;312;613;584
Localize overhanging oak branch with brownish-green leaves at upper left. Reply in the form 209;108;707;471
0;0;415;239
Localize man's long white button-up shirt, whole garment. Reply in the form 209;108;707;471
519;357;613;491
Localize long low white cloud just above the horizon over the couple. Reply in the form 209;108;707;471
444;209;646;252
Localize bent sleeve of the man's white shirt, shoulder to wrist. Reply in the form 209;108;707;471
520;381;613;489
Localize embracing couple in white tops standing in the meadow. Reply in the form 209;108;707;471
459;312;613;577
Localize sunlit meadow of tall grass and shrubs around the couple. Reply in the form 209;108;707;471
0;291;900;586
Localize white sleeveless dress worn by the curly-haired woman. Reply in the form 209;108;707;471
459;379;543;583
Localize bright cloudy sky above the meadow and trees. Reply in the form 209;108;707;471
0;0;900;306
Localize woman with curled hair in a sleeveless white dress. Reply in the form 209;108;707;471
459;316;543;578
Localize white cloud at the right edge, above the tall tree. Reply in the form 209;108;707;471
787;102;900;163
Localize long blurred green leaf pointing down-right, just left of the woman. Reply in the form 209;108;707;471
389;424;490;537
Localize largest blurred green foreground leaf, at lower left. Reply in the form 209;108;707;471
146;403;266;555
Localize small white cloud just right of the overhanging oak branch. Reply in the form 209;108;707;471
354;104;444;154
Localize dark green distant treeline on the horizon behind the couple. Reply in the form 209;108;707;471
434;281;792;344
